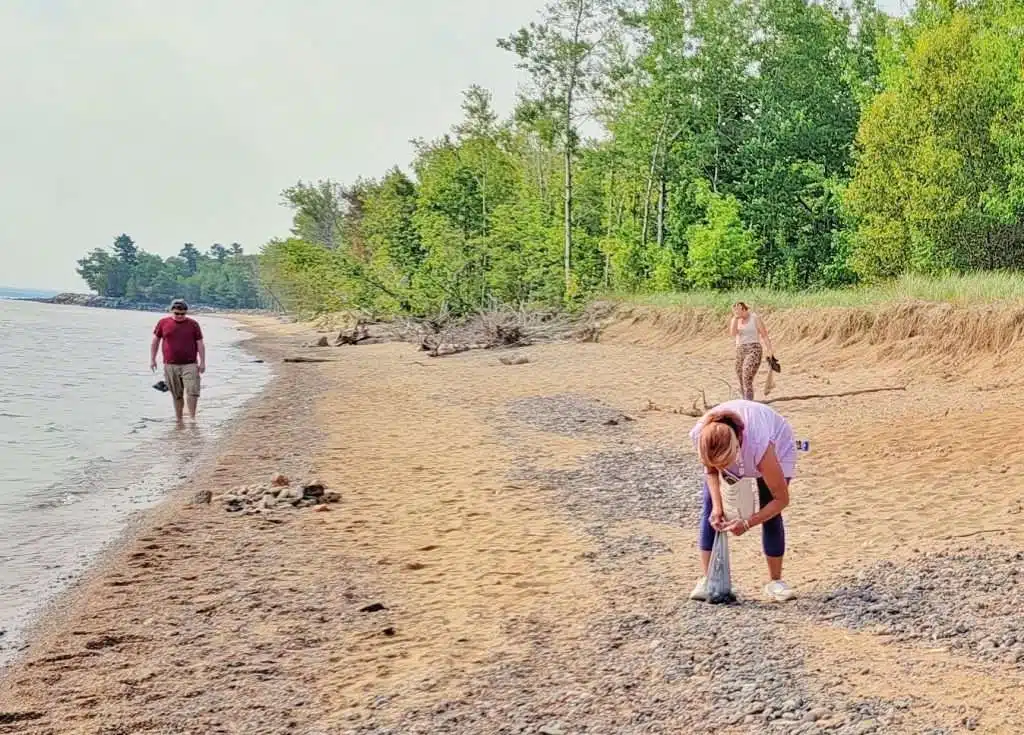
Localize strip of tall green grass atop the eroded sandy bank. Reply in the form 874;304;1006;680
612;271;1024;312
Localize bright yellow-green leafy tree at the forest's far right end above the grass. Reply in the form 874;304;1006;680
847;3;1024;278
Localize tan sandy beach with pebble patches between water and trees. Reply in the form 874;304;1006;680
0;305;1024;735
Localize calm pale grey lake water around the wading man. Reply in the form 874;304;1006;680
0;300;269;662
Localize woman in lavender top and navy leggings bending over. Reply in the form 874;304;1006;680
690;400;797;602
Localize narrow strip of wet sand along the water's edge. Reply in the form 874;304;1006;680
0;315;292;682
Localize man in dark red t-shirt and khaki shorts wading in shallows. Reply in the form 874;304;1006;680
150;299;206;425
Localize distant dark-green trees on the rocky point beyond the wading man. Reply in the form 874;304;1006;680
78;234;269;309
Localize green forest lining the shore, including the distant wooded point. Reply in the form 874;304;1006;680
82;0;1024;315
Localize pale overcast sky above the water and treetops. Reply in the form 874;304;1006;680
6;0;898;291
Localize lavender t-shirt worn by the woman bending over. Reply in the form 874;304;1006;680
690;400;797;478
